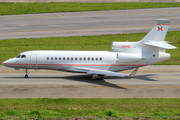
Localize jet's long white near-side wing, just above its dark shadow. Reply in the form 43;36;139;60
68;67;129;77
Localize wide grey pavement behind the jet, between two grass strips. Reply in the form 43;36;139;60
0;7;180;40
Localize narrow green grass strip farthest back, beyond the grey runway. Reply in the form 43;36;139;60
0;3;180;15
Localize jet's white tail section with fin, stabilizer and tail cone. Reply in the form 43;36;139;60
140;19;177;64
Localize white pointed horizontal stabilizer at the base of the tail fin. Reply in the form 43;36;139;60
144;41;177;49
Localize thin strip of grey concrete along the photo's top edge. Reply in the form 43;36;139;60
0;0;180;3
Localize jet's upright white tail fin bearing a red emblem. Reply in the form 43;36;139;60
141;19;170;42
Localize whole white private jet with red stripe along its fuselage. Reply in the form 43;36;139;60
2;19;176;79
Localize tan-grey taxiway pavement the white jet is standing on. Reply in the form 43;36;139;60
0;65;180;98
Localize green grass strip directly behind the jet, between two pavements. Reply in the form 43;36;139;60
0;31;180;65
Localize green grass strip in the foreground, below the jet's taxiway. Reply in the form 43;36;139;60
0;98;180;118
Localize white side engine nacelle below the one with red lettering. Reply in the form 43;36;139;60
117;53;142;63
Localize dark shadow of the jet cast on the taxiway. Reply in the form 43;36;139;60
3;74;158;89
